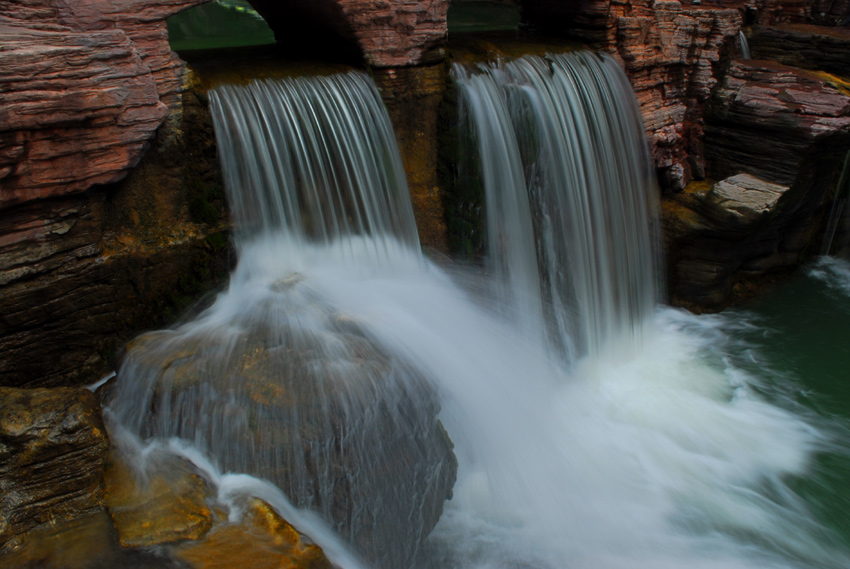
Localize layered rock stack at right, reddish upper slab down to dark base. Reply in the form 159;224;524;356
664;60;850;309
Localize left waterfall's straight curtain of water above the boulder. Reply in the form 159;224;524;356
210;73;419;253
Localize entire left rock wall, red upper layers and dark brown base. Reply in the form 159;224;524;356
0;0;232;386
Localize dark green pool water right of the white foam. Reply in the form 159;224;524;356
723;258;850;547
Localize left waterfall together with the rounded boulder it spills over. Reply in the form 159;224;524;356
110;73;456;568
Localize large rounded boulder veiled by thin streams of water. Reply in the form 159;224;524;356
109;275;457;568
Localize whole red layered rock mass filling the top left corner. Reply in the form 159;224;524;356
0;0;205;204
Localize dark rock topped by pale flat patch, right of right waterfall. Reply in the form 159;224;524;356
661;174;814;312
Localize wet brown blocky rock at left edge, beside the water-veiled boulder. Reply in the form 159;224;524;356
0;388;109;553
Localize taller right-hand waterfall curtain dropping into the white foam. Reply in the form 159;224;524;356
454;53;658;360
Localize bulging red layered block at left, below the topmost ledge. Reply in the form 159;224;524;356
0;27;168;208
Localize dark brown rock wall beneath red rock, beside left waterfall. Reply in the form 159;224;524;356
0;81;229;387
